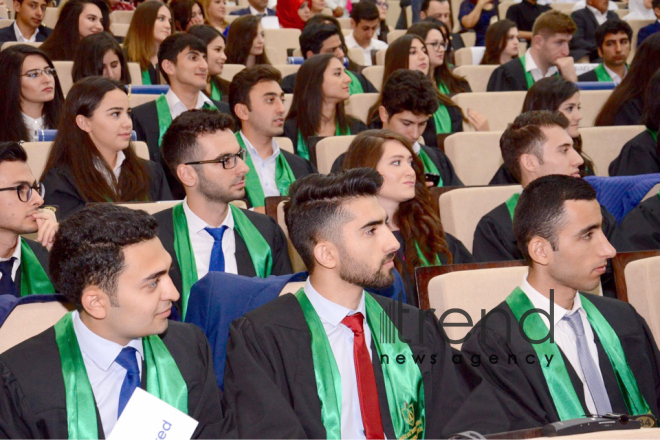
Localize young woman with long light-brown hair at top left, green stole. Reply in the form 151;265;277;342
124;0;172;84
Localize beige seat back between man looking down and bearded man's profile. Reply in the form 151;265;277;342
445;131;504;186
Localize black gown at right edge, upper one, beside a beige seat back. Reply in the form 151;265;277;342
608;130;660;176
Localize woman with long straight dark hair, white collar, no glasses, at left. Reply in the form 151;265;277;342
41;77;172;219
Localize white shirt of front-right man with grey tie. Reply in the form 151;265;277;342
520;275;602;414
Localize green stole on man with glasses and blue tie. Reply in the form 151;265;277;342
172;203;273;320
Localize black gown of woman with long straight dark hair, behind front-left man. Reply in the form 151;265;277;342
41;159;172;221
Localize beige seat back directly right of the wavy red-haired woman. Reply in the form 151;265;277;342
440;185;522;252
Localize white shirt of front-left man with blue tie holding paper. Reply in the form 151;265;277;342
72;311;144;438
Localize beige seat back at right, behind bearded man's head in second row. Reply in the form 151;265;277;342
580;125;646;176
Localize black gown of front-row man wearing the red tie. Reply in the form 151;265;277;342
225;294;509;438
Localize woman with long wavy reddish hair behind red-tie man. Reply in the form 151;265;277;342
342;130;474;306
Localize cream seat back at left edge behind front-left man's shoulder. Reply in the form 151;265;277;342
0;301;74;353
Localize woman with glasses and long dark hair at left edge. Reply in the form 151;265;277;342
0;44;64;142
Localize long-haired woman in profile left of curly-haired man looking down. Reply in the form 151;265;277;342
284;54;367;160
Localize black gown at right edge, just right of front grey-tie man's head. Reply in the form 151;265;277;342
620;195;660;251
